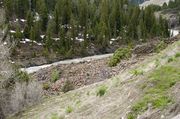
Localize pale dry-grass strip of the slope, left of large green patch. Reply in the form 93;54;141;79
13;41;180;119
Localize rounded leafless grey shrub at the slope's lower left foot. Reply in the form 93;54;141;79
10;81;42;112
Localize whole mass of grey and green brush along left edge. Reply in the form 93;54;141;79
0;37;42;118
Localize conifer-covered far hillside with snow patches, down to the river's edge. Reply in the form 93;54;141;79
4;0;170;65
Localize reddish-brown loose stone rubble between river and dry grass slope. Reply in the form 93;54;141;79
33;56;144;94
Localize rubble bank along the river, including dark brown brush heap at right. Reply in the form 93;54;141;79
32;37;178;94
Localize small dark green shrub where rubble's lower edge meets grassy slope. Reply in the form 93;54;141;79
62;80;74;93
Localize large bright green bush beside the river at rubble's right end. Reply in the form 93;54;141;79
108;48;131;67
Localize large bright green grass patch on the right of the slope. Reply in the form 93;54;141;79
128;57;180;119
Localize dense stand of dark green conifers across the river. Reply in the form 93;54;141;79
4;0;172;55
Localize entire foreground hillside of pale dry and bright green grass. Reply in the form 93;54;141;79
10;41;180;119
